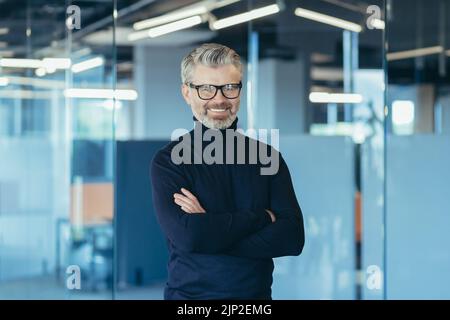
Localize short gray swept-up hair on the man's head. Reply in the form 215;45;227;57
181;43;242;83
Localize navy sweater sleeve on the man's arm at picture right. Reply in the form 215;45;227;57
227;154;305;258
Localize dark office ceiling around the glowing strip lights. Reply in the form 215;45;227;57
0;0;450;81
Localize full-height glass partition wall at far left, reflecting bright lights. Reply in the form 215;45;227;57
0;0;116;299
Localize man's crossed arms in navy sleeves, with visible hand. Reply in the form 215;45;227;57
151;154;304;258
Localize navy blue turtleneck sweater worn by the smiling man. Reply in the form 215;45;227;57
151;118;304;300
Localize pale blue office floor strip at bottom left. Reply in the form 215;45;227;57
0;276;164;300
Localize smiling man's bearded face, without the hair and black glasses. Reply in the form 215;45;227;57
181;64;241;129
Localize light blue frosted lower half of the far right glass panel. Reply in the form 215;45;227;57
386;135;450;299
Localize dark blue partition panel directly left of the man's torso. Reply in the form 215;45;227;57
115;141;168;286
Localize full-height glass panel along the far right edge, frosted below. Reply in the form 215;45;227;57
385;0;450;299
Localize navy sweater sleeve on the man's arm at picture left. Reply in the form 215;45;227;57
151;152;271;254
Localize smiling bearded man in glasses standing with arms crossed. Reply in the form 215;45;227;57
151;44;304;299
